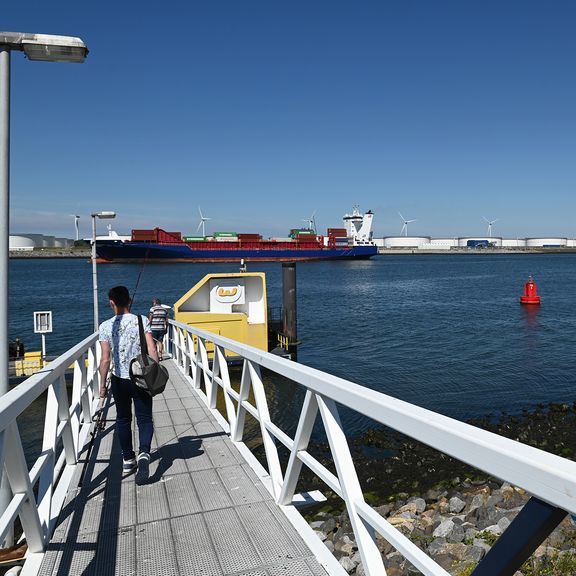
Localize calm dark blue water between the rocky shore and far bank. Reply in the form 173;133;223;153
10;254;576;440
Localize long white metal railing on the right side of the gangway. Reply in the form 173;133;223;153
169;320;576;576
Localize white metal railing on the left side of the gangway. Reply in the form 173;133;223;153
0;333;100;567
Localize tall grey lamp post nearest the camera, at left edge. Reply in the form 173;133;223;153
0;32;88;546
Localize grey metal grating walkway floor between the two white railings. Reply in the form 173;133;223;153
40;360;326;576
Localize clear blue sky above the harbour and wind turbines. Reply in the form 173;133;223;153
1;0;576;237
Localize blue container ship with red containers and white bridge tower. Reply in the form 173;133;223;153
96;207;378;262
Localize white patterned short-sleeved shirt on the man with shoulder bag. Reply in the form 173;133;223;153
99;314;150;378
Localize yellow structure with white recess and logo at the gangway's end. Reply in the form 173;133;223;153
174;272;268;355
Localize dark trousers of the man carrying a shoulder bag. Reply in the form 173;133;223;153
110;375;154;460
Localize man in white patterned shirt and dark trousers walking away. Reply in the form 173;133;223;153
98;286;158;484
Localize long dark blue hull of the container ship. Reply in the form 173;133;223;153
96;241;378;262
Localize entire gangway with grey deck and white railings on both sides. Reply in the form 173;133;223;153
0;321;576;576
